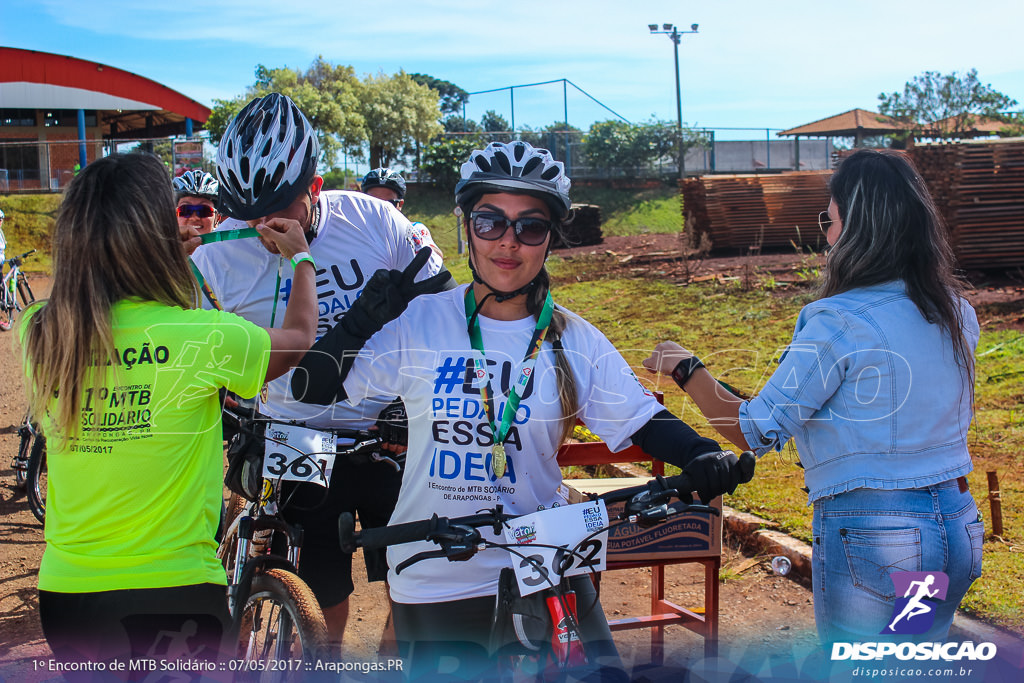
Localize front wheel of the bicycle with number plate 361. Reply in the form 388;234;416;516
238;569;329;682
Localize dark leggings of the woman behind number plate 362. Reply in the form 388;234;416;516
391;577;628;681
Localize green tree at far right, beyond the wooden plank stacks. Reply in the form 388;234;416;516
879;69;1017;137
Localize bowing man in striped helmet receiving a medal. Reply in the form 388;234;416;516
194;93;451;647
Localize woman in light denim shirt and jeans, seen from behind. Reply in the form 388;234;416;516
644;150;984;643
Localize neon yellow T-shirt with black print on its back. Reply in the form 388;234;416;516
22;300;270;593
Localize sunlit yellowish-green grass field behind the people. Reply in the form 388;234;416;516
0;187;1024;633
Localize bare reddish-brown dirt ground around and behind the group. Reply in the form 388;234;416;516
0;249;1024;683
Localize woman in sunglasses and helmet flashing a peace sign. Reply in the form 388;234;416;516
292;141;741;680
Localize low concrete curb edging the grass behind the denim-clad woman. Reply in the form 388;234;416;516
722;505;1024;668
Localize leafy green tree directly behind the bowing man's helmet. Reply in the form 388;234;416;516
206;56;366;166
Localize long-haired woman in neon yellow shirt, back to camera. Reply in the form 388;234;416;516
20;154;316;661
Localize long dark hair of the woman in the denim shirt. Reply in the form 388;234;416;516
821;150;974;382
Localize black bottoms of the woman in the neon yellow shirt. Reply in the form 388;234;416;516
39;584;231;681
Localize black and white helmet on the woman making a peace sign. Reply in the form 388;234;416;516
455;140;572;220
